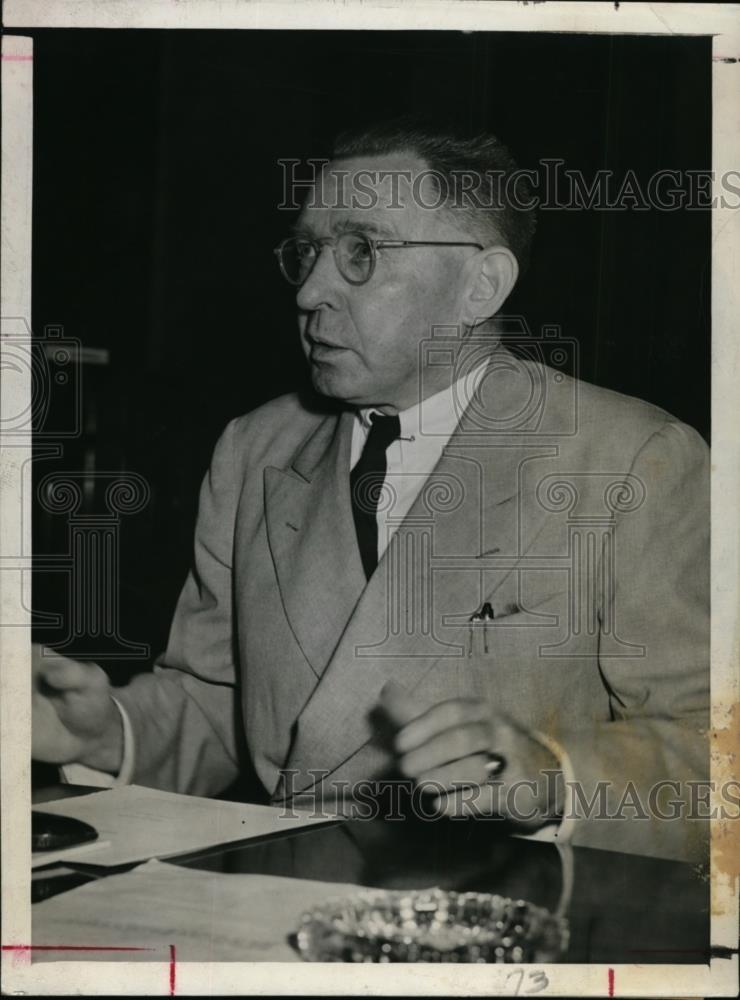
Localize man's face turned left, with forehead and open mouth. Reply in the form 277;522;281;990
296;154;475;410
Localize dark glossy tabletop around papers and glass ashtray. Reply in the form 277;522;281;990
34;787;710;964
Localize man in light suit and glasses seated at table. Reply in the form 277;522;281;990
34;123;708;856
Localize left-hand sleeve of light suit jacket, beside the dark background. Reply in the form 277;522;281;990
116;422;243;795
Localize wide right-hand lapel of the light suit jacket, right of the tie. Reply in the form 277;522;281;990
278;348;556;791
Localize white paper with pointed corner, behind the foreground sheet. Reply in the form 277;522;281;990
33;785;341;868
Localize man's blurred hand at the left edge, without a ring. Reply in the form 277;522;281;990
32;645;123;774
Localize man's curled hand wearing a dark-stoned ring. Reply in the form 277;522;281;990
381;682;562;829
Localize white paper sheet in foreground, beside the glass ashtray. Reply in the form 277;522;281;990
33;861;363;962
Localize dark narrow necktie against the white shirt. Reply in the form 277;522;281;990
349;413;401;580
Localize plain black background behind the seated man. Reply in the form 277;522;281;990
23;30;711;681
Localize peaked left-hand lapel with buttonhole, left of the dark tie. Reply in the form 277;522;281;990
265;412;365;677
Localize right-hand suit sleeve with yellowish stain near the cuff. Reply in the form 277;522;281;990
558;422;709;858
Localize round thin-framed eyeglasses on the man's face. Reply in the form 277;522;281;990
273;232;483;285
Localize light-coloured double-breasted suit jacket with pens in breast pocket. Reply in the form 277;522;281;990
117;348;709;856
